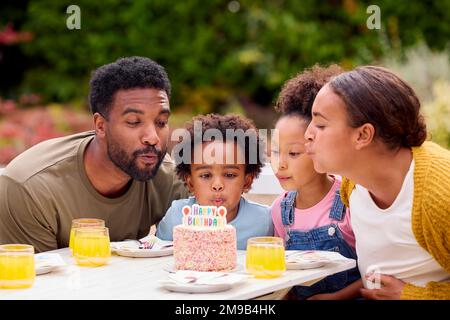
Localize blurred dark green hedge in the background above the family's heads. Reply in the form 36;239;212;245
7;0;450;112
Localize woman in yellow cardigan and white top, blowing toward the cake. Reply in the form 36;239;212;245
305;66;450;299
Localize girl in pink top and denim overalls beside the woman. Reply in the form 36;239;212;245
271;65;360;299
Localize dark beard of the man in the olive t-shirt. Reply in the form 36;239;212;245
106;138;167;181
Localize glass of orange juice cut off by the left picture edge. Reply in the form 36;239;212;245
0;244;36;289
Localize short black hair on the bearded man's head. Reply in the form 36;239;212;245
89;57;171;119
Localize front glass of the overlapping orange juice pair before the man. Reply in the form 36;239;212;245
73;227;111;267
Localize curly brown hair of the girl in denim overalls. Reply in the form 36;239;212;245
275;64;344;121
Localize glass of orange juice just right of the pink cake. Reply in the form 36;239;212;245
246;237;286;278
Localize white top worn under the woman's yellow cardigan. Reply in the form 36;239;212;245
350;160;450;287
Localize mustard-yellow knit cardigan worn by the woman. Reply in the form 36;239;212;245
341;142;450;300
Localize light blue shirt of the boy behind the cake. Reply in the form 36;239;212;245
156;197;273;250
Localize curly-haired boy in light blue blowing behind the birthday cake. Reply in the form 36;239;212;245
156;114;273;250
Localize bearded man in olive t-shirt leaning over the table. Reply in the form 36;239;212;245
0;57;187;252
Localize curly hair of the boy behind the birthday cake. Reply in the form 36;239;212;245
175;113;265;180
